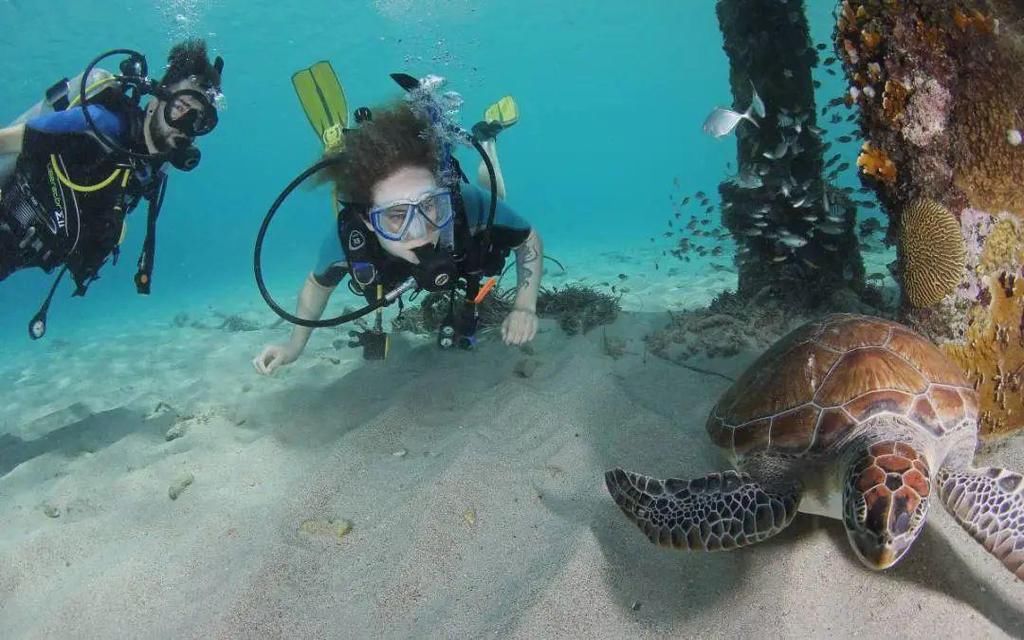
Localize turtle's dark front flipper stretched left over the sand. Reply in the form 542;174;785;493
604;469;800;551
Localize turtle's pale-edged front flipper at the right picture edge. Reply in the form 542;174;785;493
939;467;1024;580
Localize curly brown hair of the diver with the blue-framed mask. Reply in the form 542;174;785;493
321;102;439;205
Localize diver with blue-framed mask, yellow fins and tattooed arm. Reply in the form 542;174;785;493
253;62;543;375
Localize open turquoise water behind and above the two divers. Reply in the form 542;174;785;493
0;0;856;349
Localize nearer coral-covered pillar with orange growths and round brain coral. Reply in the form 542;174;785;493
836;0;1024;436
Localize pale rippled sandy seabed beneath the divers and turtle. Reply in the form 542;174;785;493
0;241;1024;638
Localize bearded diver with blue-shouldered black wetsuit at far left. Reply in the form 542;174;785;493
0;39;224;339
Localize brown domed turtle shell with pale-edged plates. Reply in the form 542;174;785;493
708;313;978;458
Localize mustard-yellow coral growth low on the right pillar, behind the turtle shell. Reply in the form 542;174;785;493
943;271;1024;437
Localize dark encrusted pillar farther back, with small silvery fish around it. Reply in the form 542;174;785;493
717;0;864;308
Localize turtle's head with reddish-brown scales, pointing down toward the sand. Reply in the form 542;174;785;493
843;441;932;569
